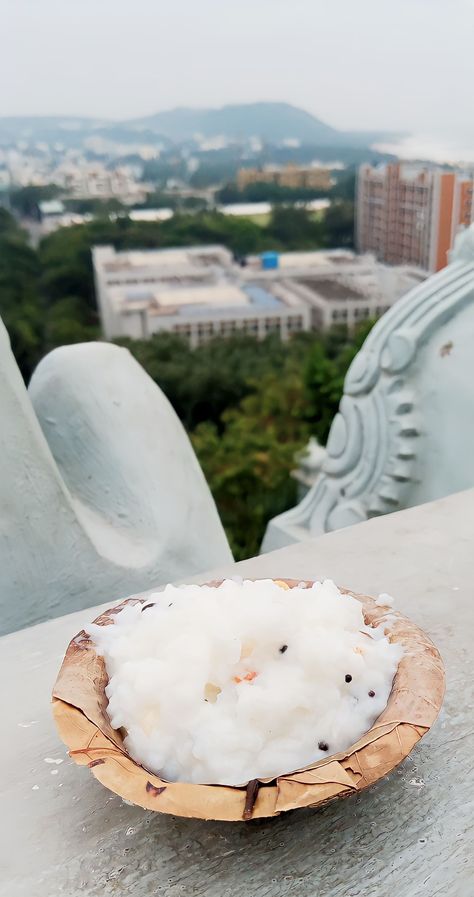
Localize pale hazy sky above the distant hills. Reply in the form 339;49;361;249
0;0;474;147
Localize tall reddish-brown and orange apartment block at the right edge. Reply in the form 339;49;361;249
356;163;474;271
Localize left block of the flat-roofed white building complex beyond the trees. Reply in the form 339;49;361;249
92;246;311;346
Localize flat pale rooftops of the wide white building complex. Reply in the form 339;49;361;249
94;245;424;323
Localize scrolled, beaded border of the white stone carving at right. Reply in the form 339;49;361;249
262;226;474;551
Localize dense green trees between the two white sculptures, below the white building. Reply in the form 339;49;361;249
120;324;370;559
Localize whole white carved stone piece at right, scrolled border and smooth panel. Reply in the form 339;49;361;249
262;226;474;551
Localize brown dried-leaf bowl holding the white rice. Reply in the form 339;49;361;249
52;579;445;821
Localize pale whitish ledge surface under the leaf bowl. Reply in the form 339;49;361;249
0;491;474;897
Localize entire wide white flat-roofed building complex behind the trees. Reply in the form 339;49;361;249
92;246;424;346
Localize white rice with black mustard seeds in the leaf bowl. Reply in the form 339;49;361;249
89;579;402;785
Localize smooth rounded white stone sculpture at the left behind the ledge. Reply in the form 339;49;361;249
0;321;232;633
